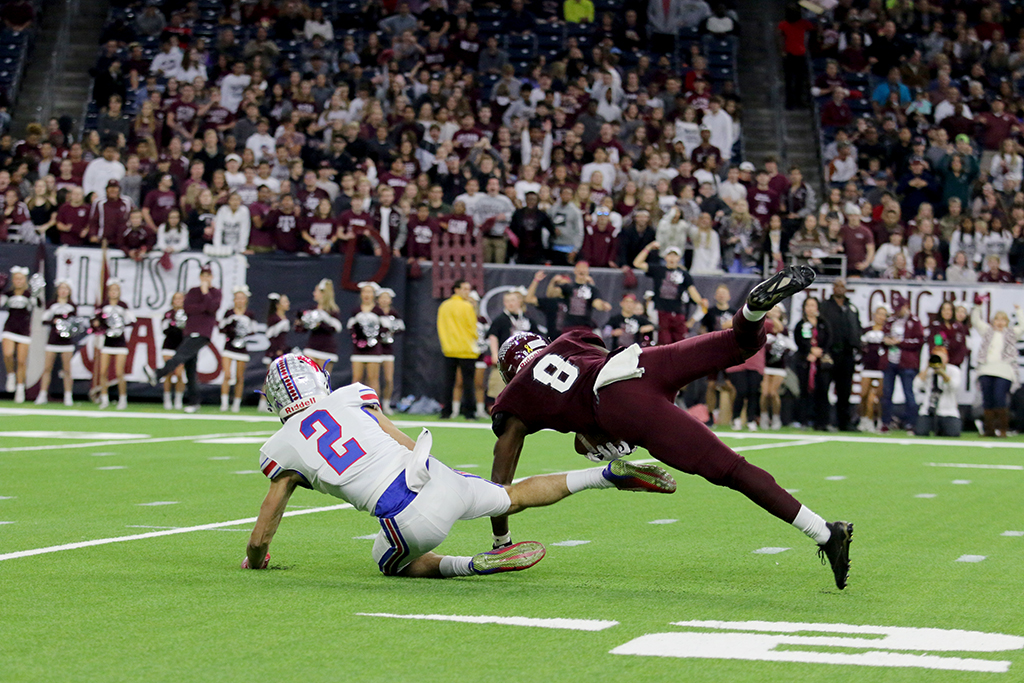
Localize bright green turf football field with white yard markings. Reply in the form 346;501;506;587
0;402;1024;683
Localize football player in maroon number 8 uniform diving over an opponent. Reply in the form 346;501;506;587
490;266;853;589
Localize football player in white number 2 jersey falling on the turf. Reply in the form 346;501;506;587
242;353;676;578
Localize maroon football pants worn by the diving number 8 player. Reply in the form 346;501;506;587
597;311;800;522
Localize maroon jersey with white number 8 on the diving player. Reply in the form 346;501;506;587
492;330;610;436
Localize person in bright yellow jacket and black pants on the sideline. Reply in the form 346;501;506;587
437;280;478;420
